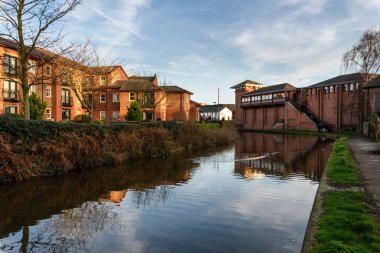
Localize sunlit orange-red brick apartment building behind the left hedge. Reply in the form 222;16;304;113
0;38;199;121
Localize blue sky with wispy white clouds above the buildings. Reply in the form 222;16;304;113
65;0;380;104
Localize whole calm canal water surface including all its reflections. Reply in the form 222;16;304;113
0;133;332;253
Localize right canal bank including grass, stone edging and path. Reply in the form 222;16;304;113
301;138;380;253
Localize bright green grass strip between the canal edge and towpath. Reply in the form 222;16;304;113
311;138;380;253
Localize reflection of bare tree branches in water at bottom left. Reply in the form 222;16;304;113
2;201;121;252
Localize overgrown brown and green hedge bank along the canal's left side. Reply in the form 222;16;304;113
0;117;234;183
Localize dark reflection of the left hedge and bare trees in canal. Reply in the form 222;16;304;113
0;155;200;252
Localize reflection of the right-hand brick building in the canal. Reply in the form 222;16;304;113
235;133;332;182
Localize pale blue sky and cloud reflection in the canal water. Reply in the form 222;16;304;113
0;146;318;252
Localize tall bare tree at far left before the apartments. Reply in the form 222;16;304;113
0;0;81;119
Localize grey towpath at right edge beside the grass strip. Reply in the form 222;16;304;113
349;138;380;217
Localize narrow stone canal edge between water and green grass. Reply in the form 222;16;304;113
301;161;331;253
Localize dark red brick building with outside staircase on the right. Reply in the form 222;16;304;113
231;73;380;132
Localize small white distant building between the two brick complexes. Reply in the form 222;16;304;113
200;104;235;120
